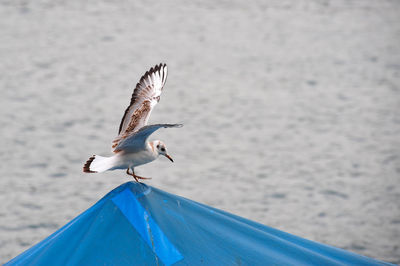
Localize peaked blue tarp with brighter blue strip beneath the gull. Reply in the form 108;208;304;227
6;182;389;265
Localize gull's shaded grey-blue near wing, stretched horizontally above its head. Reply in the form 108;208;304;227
114;124;183;152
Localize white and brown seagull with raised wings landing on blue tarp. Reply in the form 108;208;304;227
83;64;183;182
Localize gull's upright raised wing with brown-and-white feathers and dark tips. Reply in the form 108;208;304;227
112;64;167;148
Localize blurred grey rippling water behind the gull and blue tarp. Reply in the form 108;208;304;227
0;0;400;263
